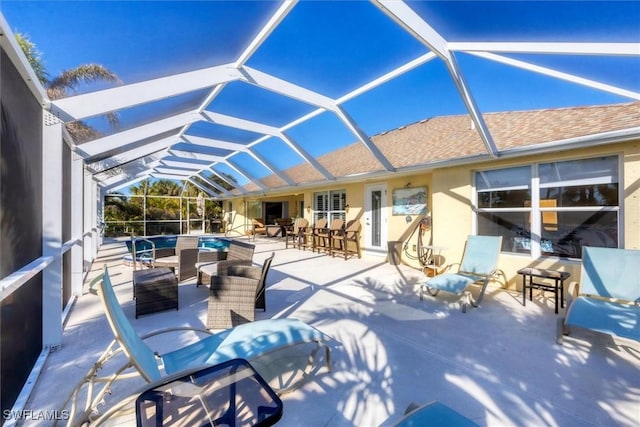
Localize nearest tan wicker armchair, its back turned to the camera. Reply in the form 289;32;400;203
207;252;275;329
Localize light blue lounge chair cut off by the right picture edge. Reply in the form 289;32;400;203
557;247;640;344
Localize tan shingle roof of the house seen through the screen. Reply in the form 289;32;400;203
262;102;640;188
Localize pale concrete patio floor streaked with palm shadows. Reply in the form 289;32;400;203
24;238;640;426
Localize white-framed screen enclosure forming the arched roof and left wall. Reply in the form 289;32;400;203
0;0;640;422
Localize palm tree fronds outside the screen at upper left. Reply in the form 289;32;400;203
16;33;121;142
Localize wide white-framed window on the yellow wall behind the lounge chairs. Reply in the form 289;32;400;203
475;156;620;258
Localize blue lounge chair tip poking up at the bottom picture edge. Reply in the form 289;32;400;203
392;401;478;427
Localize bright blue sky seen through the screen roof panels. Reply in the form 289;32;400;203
0;0;640;189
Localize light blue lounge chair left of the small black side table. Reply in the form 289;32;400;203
420;236;502;313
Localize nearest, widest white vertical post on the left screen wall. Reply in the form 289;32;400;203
42;111;63;351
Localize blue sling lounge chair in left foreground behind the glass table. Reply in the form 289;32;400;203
62;266;331;425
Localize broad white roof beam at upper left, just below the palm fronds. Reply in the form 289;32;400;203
51;64;242;121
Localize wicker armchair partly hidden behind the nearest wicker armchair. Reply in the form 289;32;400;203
195;240;256;286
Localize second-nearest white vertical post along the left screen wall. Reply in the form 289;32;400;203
71;153;84;296
